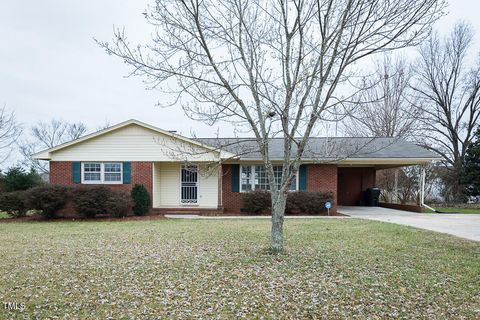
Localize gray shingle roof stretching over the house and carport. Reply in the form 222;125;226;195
195;137;438;160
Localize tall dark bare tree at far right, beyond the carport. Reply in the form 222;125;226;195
412;23;480;201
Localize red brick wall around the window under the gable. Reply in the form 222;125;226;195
50;161;153;204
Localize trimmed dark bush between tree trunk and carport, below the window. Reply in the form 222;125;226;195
285;191;333;214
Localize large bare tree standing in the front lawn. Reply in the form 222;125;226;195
99;0;445;252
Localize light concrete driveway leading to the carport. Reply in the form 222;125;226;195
337;206;480;241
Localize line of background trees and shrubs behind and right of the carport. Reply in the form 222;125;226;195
344;22;480;203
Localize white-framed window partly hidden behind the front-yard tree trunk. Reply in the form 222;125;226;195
240;165;297;192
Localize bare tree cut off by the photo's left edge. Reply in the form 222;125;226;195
0;106;22;164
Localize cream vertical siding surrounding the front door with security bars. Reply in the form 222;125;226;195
152;162;219;208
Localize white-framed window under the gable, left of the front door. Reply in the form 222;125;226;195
82;162;122;184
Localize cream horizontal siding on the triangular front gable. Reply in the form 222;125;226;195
51;124;219;162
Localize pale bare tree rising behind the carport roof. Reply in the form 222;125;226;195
345;55;420;138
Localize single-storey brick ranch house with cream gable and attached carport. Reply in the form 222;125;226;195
33;120;437;214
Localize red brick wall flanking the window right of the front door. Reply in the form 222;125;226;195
222;164;337;214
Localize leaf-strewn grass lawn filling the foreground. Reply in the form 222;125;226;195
0;219;480;319
